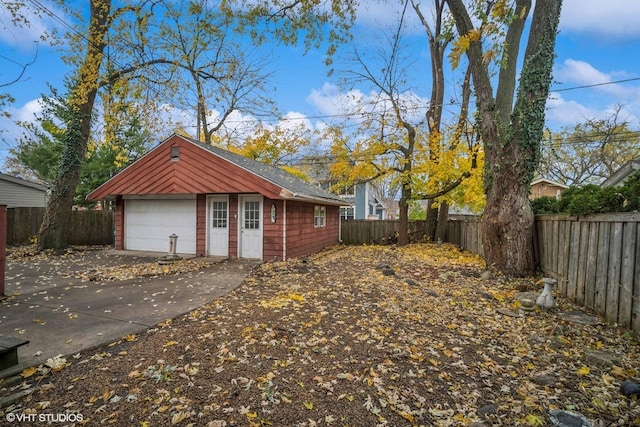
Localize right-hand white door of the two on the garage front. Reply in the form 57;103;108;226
238;196;262;259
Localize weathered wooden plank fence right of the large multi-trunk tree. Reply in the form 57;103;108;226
536;213;640;331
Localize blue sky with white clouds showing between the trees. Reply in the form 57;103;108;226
0;0;640;165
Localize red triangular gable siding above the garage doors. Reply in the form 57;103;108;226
88;135;281;200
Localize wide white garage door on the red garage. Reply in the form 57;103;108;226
124;199;196;254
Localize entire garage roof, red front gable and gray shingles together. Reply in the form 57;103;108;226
87;134;345;206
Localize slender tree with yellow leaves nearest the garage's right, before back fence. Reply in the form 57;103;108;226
333;1;424;245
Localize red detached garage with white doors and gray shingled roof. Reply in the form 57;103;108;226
87;135;345;260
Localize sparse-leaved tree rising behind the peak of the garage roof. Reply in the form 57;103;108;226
146;0;275;144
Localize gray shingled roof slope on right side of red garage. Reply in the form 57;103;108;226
183;137;347;206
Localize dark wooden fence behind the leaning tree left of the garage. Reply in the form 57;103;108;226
7;208;113;245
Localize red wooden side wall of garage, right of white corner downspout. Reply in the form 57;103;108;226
287;202;340;258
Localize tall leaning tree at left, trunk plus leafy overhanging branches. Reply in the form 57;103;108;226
5;0;355;250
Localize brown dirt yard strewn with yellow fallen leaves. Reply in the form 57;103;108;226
0;244;640;427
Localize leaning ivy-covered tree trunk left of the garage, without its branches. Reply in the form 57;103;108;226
38;0;111;251
